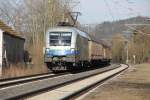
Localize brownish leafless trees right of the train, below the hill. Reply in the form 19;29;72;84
112;26;150;64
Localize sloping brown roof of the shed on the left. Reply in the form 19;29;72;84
0;20;25;40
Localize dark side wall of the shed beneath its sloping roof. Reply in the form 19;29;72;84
3;33;25;63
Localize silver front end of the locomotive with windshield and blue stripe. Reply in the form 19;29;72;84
45;27;78;70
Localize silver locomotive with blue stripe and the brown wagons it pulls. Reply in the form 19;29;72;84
44;23;111;71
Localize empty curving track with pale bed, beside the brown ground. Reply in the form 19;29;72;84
27;65;128;100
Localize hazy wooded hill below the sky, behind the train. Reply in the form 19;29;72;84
93;16;150;39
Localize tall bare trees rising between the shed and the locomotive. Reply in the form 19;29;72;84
0;0;76;64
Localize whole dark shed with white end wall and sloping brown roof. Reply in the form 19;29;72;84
0;21;25;66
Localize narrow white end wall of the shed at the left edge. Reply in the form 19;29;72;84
0;29;3;77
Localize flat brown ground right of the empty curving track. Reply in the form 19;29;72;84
80;64;150;100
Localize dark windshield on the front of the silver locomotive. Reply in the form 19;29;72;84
49;32;72;46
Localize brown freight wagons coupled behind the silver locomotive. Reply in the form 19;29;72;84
89;35;111;65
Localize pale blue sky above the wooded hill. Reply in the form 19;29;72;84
74;0;150;24
